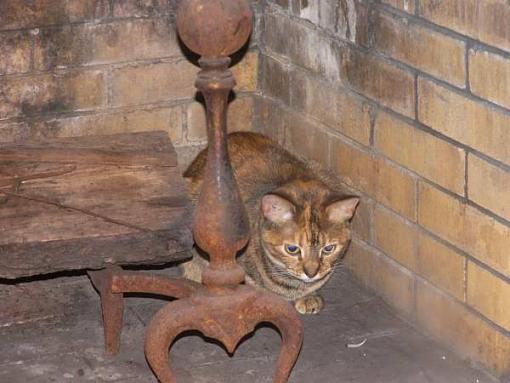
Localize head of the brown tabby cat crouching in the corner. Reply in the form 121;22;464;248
260;187;359;283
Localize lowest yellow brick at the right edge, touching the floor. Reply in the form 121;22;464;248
416;283;510;375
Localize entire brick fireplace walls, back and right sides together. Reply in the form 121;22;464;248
0;0;510;375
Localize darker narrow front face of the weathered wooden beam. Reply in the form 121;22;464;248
0;225;192;279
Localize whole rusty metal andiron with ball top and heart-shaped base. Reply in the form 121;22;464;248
89;0;303;383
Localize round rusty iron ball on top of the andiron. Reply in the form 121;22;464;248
177;0;252;58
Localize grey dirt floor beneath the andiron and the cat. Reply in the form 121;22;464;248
0;271;497;383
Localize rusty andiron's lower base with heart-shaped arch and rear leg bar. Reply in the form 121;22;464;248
89;267;303;383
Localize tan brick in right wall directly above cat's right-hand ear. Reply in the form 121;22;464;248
331;138;416;220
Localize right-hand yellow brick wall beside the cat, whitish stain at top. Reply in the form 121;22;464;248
256;0;510;375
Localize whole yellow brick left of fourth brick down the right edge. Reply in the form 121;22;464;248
375;112;465;194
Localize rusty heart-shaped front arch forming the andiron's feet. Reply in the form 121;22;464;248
145;285;303;383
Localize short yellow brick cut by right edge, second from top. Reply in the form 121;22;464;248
469;50;510;108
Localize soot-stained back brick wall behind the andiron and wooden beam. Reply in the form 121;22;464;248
0;0;258;164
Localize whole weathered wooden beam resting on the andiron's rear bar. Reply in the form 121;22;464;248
0;132;192;278
